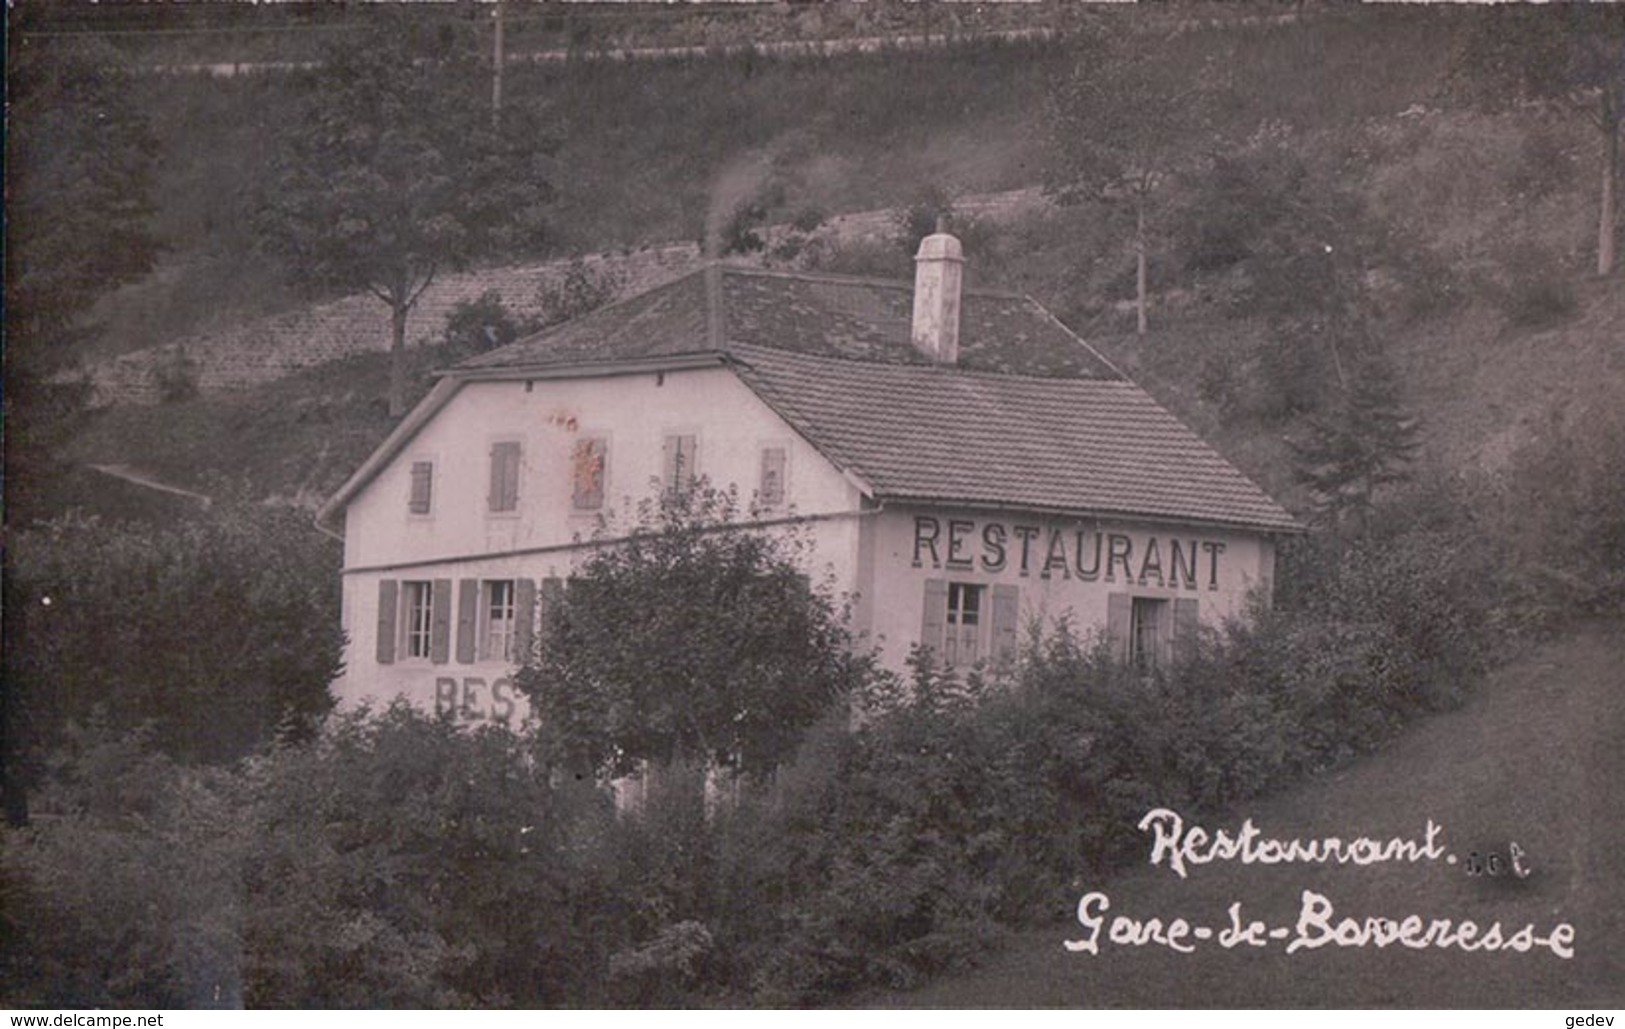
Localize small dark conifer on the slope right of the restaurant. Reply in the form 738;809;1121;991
1292;359;1420;535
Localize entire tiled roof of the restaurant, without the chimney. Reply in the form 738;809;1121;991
377;265;1300;532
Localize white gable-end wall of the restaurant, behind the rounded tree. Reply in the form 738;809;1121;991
335;367;860;717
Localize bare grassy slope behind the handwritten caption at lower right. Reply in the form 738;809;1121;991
871;623;1625;1008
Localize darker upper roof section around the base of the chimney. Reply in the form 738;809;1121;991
460;265;1118;379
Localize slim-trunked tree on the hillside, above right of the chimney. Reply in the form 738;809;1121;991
1045;26;1207;335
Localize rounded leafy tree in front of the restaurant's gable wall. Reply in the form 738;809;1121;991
517;483;866;774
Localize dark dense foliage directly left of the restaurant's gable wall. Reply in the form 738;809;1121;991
5;504;341;787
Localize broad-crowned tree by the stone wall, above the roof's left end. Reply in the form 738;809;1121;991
258;24;553;416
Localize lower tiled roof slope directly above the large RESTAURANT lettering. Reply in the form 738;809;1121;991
731;348;1298;532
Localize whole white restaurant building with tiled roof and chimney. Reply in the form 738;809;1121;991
319;234;1298;719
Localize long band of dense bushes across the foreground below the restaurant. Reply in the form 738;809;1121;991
0;474;1534;1006
